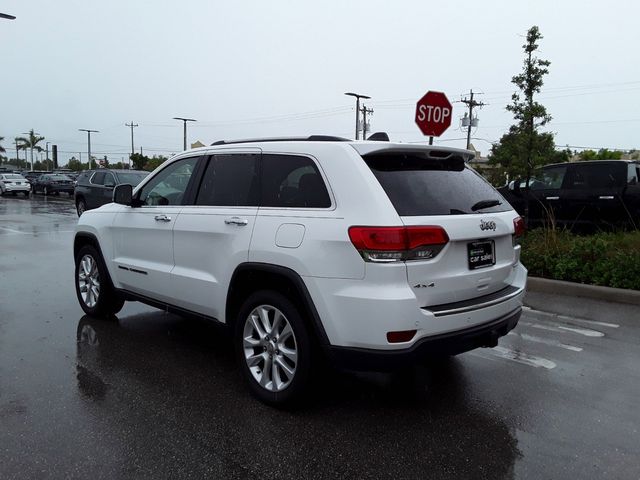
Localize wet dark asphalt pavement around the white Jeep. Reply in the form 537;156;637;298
0;196;640;480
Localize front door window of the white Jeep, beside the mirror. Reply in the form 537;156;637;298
138;157;200;206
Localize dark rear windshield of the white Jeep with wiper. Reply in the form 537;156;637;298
363;152;511;217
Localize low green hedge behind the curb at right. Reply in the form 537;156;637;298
521;228;640;290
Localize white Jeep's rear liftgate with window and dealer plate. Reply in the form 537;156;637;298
363;151;518;306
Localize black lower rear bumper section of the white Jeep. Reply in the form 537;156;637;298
326;307;522;371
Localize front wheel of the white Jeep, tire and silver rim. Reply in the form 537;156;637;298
74;245;124;317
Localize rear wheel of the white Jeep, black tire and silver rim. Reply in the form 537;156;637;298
234;290;311;406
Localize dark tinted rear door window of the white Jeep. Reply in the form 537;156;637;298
196;153;260;207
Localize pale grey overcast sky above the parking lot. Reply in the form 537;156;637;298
0;0;640;163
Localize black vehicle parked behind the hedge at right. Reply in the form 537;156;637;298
498;160;640;231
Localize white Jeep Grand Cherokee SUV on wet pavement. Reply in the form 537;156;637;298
74;136;527;404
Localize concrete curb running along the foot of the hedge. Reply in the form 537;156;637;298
527;277;640;305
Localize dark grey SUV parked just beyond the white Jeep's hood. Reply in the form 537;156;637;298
74;169;149;216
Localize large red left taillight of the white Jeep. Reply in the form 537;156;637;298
349;226;449;262
